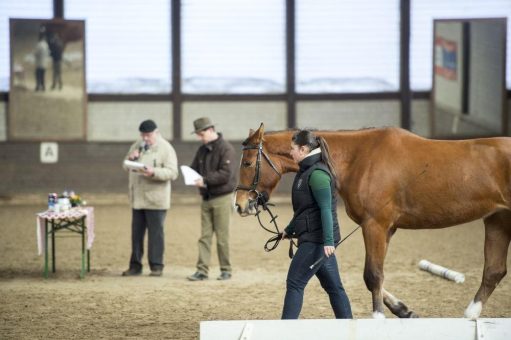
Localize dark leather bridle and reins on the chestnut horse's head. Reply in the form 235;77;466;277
236;139;292;251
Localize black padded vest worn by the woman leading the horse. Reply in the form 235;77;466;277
291;154;341;244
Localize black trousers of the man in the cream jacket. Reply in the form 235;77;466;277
130;209;167;270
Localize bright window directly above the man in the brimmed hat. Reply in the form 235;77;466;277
181;0;286;94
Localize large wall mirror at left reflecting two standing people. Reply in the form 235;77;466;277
8;19;87;141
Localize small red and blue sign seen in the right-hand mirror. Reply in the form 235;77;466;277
435;37;458;80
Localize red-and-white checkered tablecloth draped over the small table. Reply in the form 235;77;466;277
36;207;94;255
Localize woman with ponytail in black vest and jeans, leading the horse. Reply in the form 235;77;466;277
282;130;352;319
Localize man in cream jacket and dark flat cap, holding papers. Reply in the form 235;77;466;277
122;119;178;276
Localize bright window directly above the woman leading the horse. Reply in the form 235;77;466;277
296;0;400;93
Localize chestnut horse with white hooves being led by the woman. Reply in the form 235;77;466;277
236;124;511;319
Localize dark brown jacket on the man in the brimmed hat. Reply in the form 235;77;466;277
190;133;236;200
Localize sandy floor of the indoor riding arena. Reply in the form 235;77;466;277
0;204;511;339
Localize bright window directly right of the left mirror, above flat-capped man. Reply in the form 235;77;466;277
64;0;172;93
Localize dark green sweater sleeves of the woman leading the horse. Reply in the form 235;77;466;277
285;169;334;246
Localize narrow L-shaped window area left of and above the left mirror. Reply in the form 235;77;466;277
0;0;53;92
